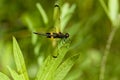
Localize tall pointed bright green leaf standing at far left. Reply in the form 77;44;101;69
13;37;29;80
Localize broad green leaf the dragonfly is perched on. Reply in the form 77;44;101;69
36;41;70;80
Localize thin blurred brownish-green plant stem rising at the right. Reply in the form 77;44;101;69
99;27;117;80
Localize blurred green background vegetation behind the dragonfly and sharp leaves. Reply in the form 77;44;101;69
0;0;120;80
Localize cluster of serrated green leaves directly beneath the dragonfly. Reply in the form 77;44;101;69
36;41;79;80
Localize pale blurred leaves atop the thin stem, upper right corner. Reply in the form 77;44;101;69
100;0;120;27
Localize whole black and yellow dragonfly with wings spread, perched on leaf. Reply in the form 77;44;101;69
33;0;69;58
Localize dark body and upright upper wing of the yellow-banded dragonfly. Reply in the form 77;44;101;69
33;1;69;39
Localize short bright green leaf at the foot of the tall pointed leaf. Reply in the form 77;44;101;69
8;67;25;80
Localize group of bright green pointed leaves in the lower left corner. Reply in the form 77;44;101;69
1;37;29;80
